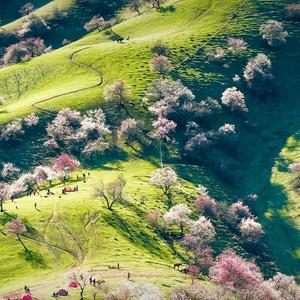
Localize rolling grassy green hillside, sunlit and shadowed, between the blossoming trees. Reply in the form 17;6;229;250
0;0;300;296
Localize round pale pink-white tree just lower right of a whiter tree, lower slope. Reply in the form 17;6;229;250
189;216;216;246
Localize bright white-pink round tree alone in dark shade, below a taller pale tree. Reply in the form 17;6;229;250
221;87;248;112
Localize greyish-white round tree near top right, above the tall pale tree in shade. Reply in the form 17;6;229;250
259;20;288;47
